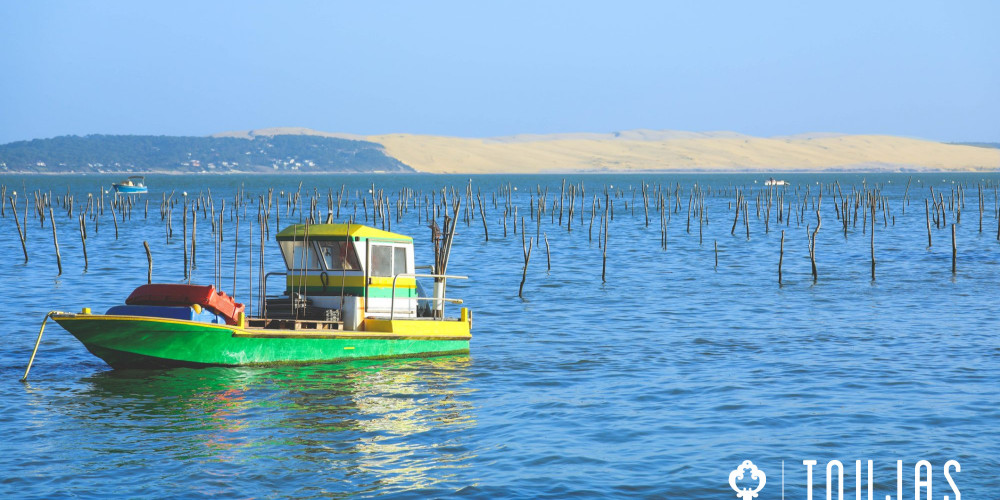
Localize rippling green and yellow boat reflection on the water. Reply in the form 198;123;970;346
76;355;476;496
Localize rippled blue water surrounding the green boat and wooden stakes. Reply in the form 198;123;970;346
0;174;1000;500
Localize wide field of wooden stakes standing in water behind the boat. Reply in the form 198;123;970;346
0;177;1000;305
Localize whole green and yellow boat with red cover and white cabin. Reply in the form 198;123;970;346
44;224;472;370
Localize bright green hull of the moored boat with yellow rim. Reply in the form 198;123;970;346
53;314;470;368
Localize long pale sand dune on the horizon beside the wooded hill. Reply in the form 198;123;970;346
220;128;1000;174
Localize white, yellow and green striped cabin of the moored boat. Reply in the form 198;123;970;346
265;224;427;323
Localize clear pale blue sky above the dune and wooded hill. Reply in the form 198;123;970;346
0;0;1000;143
